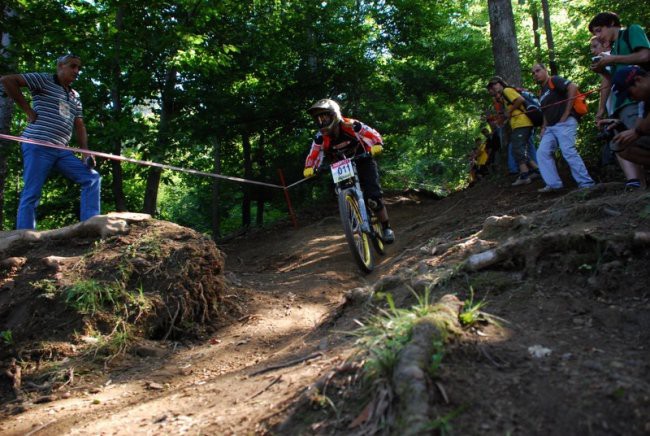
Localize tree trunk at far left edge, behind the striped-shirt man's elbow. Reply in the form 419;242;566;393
0;8;14;230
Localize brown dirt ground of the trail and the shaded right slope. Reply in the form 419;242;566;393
0;165;650;435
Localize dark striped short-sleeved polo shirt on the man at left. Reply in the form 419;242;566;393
22;73;83;145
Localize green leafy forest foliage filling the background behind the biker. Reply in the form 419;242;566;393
0;0;632;236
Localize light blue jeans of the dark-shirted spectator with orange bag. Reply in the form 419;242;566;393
537;117;594;189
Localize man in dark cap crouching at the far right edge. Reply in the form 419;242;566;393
603;65;650;165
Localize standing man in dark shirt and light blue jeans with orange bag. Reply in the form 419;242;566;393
533;63;594;192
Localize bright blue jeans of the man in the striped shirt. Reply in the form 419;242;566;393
16;142;101;229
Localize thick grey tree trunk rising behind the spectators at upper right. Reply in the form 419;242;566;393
488;0;521;86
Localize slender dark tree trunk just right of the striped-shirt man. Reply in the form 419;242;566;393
111;6;127;212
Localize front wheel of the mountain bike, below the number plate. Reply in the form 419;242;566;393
339;190;375;272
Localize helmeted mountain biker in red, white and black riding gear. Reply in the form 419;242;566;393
303;98;395;244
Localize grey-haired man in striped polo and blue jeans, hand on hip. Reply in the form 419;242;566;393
0;54;101;229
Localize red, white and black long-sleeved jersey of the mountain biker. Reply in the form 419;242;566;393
305;118;383;168
